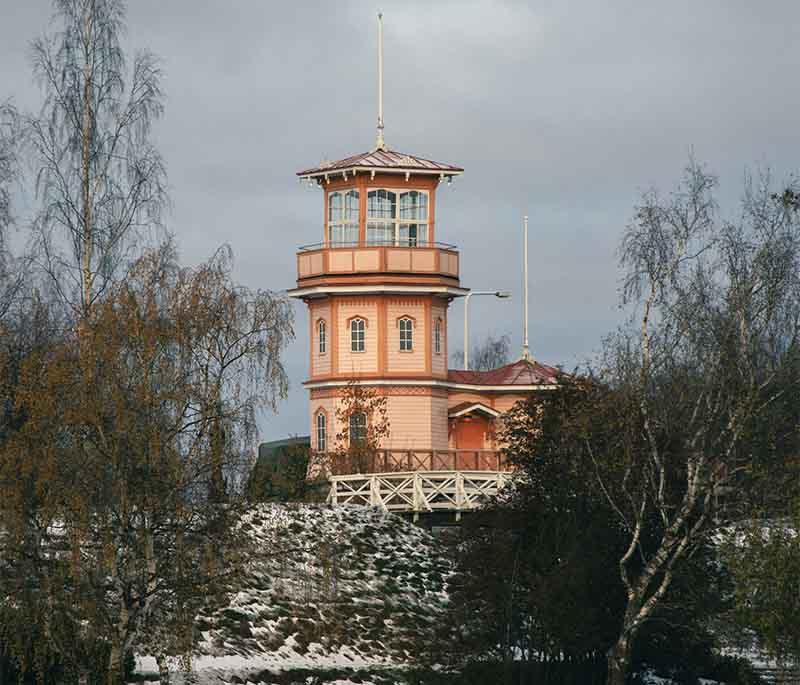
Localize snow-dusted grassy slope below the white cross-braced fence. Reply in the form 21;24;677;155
140;505;450;685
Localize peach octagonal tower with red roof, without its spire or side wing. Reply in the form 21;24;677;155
290;149;467;451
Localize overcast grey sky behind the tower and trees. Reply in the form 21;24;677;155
0;0;800;439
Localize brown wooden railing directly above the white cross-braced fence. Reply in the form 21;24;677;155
319;449;510;475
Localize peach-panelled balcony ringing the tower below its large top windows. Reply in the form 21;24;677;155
297;241;459;287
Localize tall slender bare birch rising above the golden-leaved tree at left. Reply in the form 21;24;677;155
26;0;166;317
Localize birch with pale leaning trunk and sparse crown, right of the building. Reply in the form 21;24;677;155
600;161;800;685
